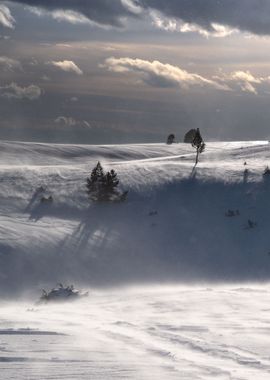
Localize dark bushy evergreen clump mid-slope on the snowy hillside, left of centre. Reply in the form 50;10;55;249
86;162;127;201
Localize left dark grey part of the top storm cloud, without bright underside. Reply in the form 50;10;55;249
7;0;140;27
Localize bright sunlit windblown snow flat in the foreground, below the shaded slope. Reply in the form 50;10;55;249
0;286;270;380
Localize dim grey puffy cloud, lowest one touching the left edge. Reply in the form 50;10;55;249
0;82;41;100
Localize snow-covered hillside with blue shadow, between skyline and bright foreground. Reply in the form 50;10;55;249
0;141;270;295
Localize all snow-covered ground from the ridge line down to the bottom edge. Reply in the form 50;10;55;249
0;141;270;380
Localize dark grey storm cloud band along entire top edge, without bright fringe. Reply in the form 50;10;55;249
10;0;270;35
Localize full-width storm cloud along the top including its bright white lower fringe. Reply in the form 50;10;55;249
8;0;270;37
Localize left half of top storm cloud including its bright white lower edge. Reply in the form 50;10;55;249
10;0;140;27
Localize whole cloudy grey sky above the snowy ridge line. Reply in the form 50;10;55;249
0;0;270;144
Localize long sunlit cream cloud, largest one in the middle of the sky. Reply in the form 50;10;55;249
103;57;229;91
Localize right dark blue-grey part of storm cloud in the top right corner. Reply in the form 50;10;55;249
140;0;270;35
